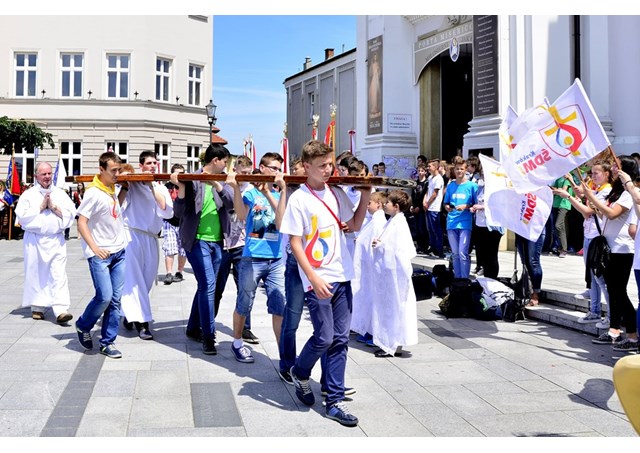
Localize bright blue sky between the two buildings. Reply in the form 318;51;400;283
213;15;356;157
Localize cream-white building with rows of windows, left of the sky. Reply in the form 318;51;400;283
0;15;213;183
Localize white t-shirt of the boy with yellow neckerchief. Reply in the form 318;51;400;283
77;187;127;258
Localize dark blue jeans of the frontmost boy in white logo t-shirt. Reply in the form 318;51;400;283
293;282;353;407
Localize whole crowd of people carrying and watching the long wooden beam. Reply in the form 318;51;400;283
11;140;640;426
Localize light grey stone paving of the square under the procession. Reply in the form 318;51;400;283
0;233;637;440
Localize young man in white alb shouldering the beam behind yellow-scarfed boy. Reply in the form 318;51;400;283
118;151;173;340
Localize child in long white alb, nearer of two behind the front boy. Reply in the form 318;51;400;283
371;190;418;357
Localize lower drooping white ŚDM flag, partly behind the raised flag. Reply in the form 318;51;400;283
479;154;553;241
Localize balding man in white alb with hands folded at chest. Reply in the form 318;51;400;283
16;162;76;324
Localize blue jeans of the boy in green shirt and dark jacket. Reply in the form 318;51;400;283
185;239;222;340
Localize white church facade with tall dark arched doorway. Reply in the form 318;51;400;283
287;15;640;176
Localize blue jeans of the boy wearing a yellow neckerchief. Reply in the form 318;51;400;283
76;249;125;346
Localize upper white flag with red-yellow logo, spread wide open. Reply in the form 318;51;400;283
503;79;610;193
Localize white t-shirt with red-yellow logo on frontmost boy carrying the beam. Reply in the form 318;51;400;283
280;185;355;291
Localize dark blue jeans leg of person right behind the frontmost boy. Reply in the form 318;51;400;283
280;253;304;371
